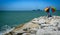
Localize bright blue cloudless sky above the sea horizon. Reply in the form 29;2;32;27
0;0;60;10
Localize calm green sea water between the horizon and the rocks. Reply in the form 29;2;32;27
0;11;60;27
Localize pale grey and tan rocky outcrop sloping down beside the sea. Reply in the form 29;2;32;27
4;16;60;35
